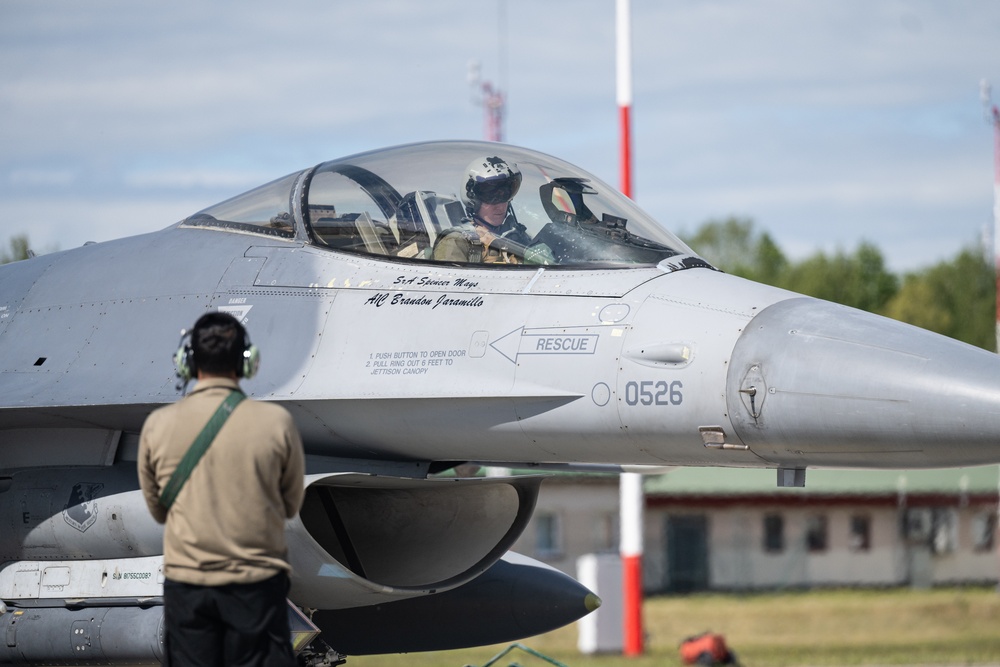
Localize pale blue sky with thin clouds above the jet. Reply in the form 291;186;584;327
0;0;1000;271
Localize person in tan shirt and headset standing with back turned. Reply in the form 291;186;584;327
138;312;304;667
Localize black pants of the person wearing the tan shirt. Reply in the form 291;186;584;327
163;572;295;667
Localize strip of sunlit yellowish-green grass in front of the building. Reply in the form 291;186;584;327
348;587;1000;667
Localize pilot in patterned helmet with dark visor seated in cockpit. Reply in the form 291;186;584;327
434;156;548;264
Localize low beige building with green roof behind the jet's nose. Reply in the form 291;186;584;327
514;466;1000;593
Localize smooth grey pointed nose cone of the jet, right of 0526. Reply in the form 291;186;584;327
727;298;1000;468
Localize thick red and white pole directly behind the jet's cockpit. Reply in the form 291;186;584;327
615;0;645;656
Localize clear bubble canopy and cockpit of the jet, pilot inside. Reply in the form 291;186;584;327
181;142;694;268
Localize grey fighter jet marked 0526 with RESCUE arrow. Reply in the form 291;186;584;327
0;142;1000;664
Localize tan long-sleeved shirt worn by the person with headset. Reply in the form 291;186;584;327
138;378;305;586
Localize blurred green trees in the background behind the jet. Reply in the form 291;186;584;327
0;223;996;351
